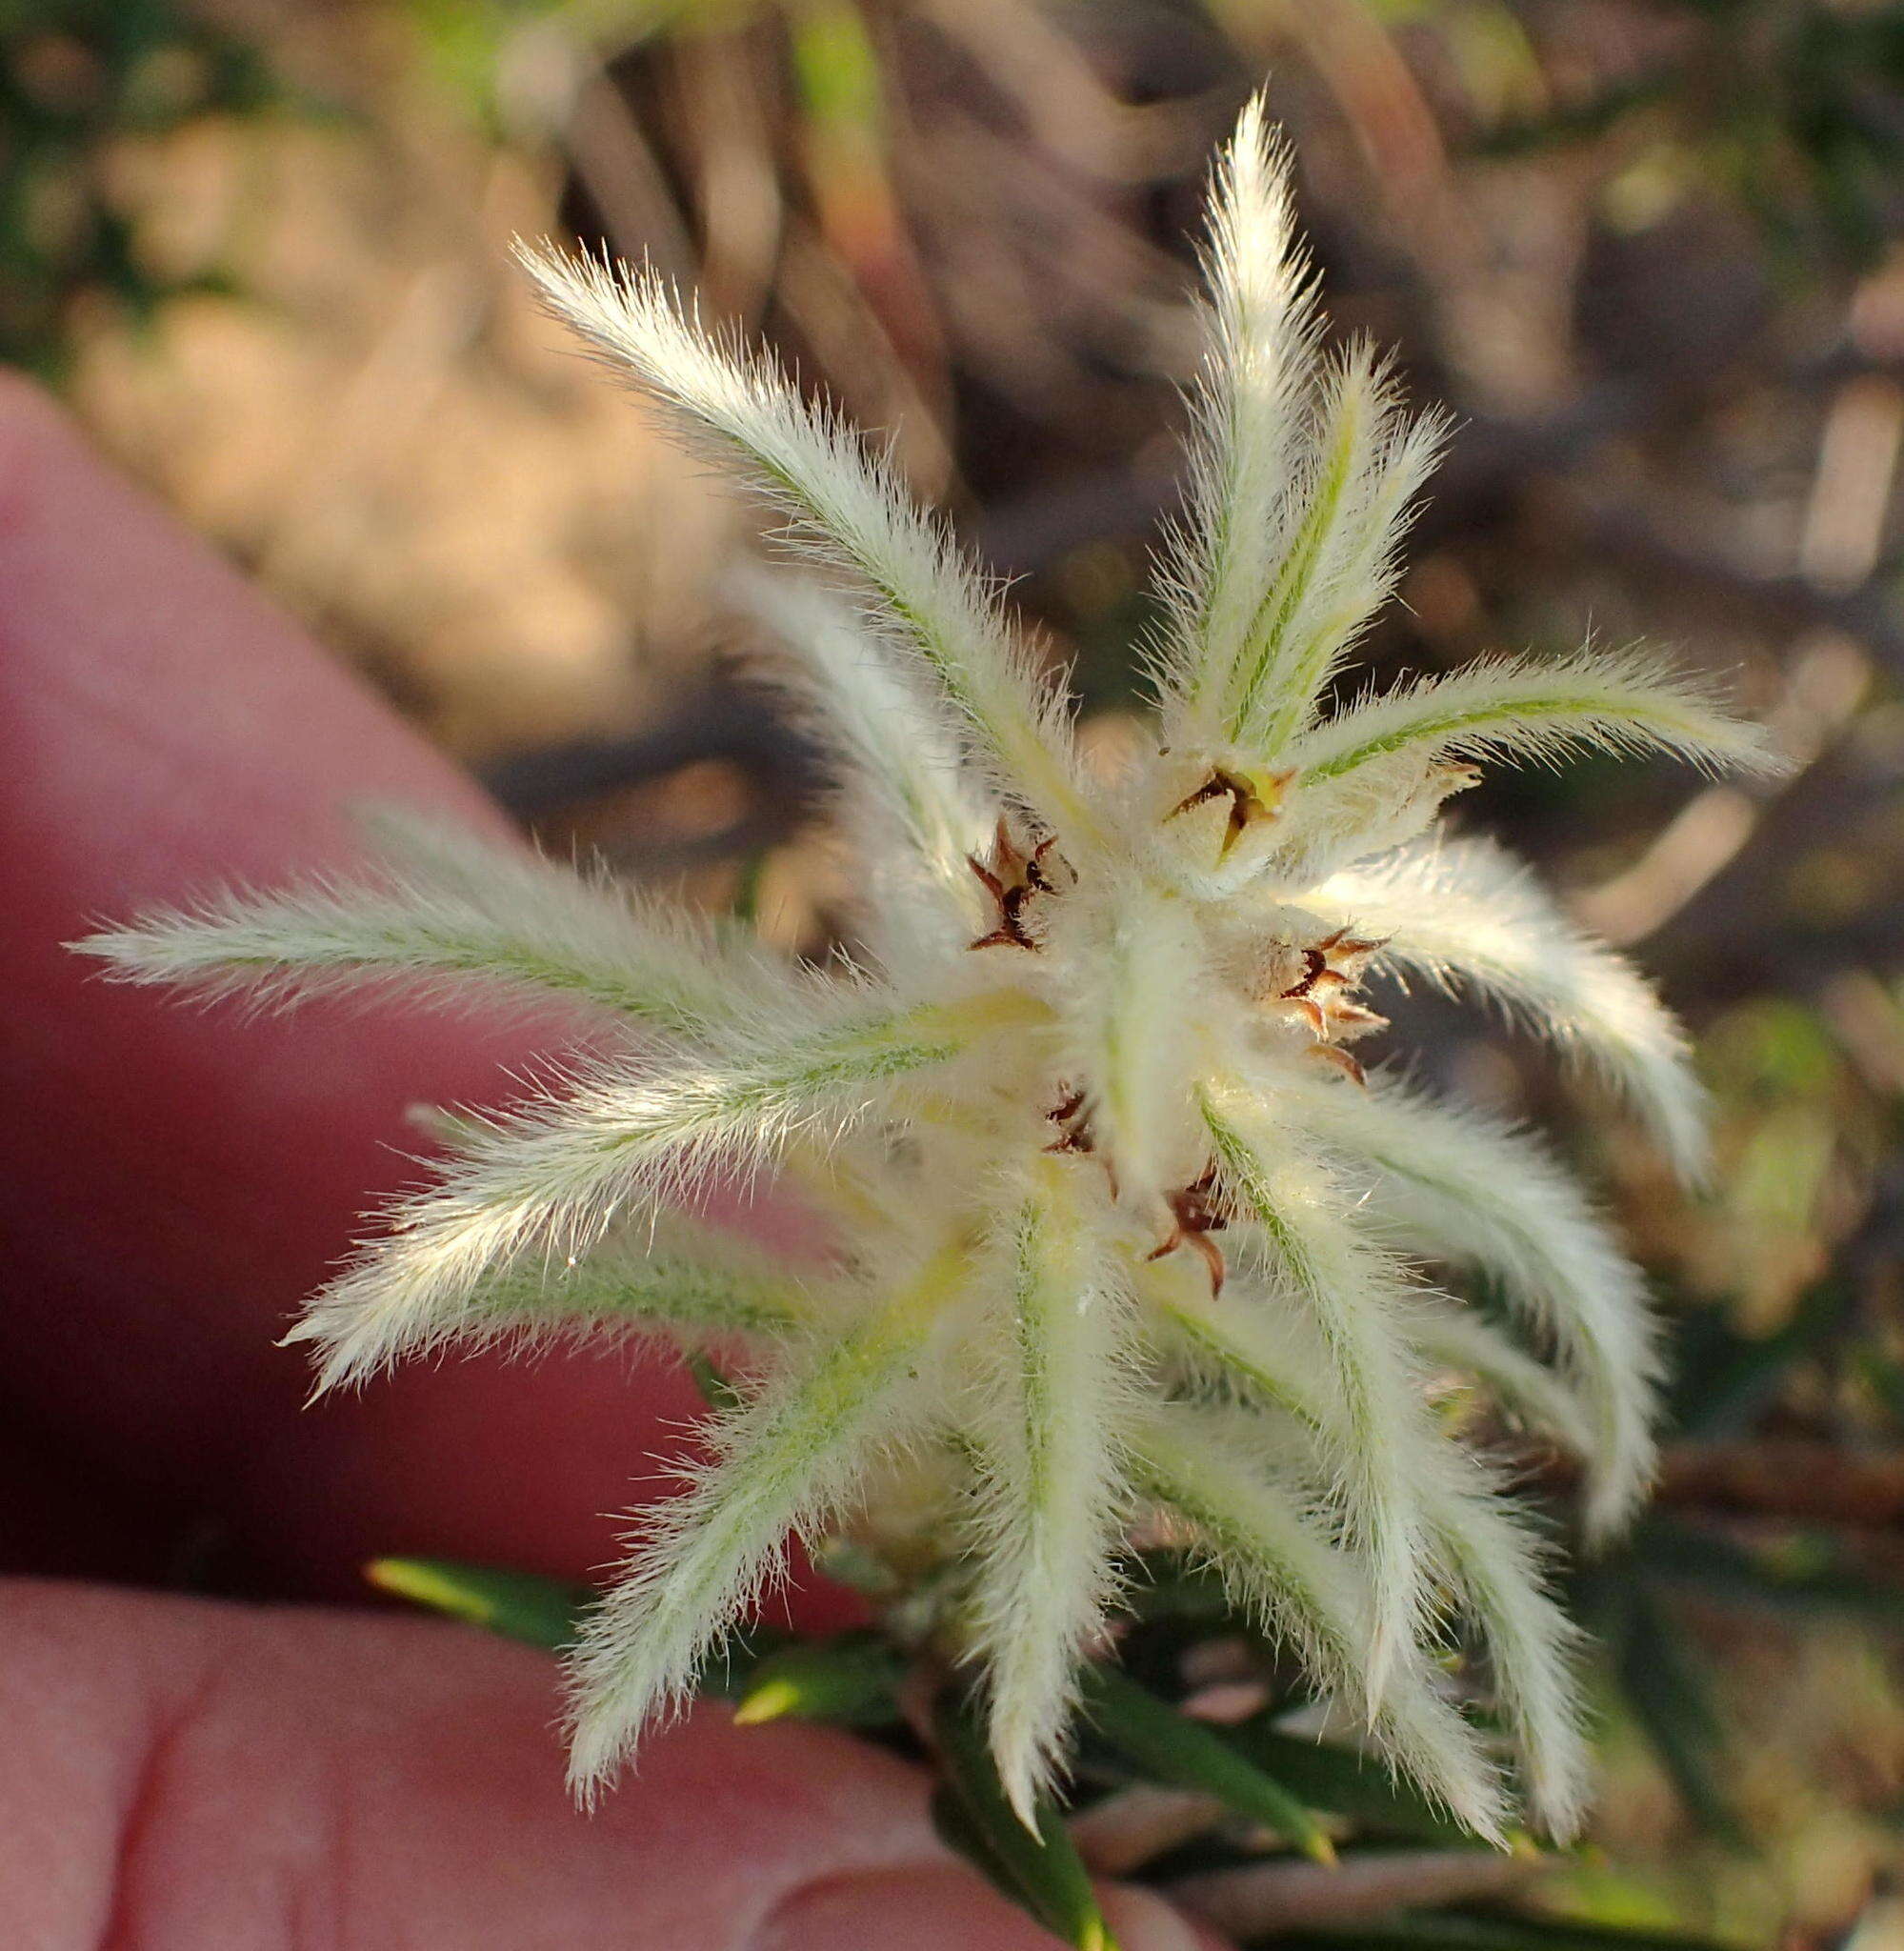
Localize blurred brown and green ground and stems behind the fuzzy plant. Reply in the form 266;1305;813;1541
0;0;1904;1951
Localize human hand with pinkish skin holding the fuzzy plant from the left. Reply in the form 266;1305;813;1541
0;380;1210;1951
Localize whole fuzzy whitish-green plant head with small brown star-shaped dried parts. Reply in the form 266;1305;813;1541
88;108;1768;1836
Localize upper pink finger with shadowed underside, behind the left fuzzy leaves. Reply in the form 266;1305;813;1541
0;382;825;1603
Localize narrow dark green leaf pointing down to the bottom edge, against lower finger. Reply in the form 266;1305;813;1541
932;1688;1118;1951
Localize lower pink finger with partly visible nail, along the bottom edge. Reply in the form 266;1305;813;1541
0;1584;1204;1951
